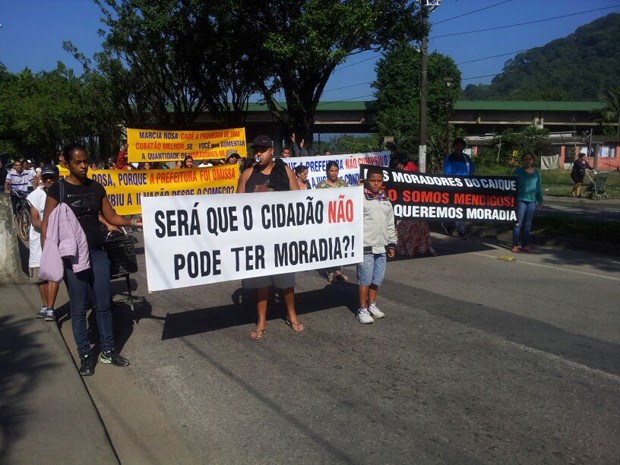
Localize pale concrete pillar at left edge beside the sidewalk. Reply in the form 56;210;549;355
0;194;28;286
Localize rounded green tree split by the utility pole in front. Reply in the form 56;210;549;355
372;44;461;169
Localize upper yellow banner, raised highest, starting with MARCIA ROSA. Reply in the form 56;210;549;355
127;128;247;163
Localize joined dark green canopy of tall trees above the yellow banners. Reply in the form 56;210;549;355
88;0;419;141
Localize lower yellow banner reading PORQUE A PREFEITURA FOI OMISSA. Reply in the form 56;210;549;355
61;164;239;215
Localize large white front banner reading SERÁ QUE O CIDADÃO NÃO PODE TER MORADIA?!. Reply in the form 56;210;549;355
142;187;363;291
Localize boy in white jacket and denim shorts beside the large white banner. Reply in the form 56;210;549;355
356;166;396;324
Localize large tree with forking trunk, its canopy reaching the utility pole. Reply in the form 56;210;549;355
231;0;420;147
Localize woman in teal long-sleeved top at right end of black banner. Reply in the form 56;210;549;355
512;152;543;253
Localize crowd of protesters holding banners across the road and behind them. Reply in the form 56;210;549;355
0;134;542;376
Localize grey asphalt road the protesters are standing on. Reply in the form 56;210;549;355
54;231;620;465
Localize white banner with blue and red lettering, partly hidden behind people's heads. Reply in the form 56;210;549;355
282;152;390;189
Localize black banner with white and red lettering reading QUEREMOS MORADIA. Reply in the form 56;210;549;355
360;166;517;222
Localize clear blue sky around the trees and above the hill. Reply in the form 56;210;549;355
0;0;620;101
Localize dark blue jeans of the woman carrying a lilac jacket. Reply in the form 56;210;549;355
65;247;114;357
